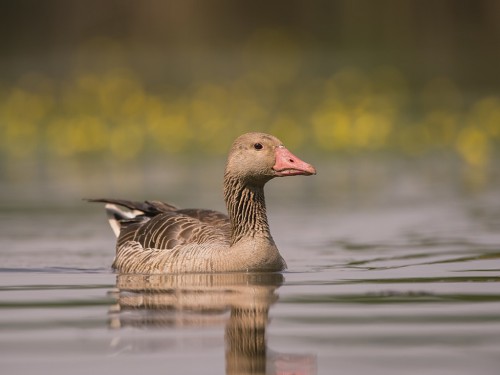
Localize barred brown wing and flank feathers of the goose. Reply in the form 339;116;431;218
113;209;231;273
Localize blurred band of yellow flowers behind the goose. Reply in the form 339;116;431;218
0;34;500;170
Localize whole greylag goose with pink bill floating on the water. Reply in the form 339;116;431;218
90;133;316;274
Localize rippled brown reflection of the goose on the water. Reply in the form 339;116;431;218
109;273;316;375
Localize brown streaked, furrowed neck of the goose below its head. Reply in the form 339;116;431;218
224;171;273;245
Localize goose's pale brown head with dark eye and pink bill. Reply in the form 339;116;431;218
226;133;316;185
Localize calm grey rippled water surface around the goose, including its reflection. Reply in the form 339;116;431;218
0;159;500;375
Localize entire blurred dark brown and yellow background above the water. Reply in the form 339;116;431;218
0;0;500;206
